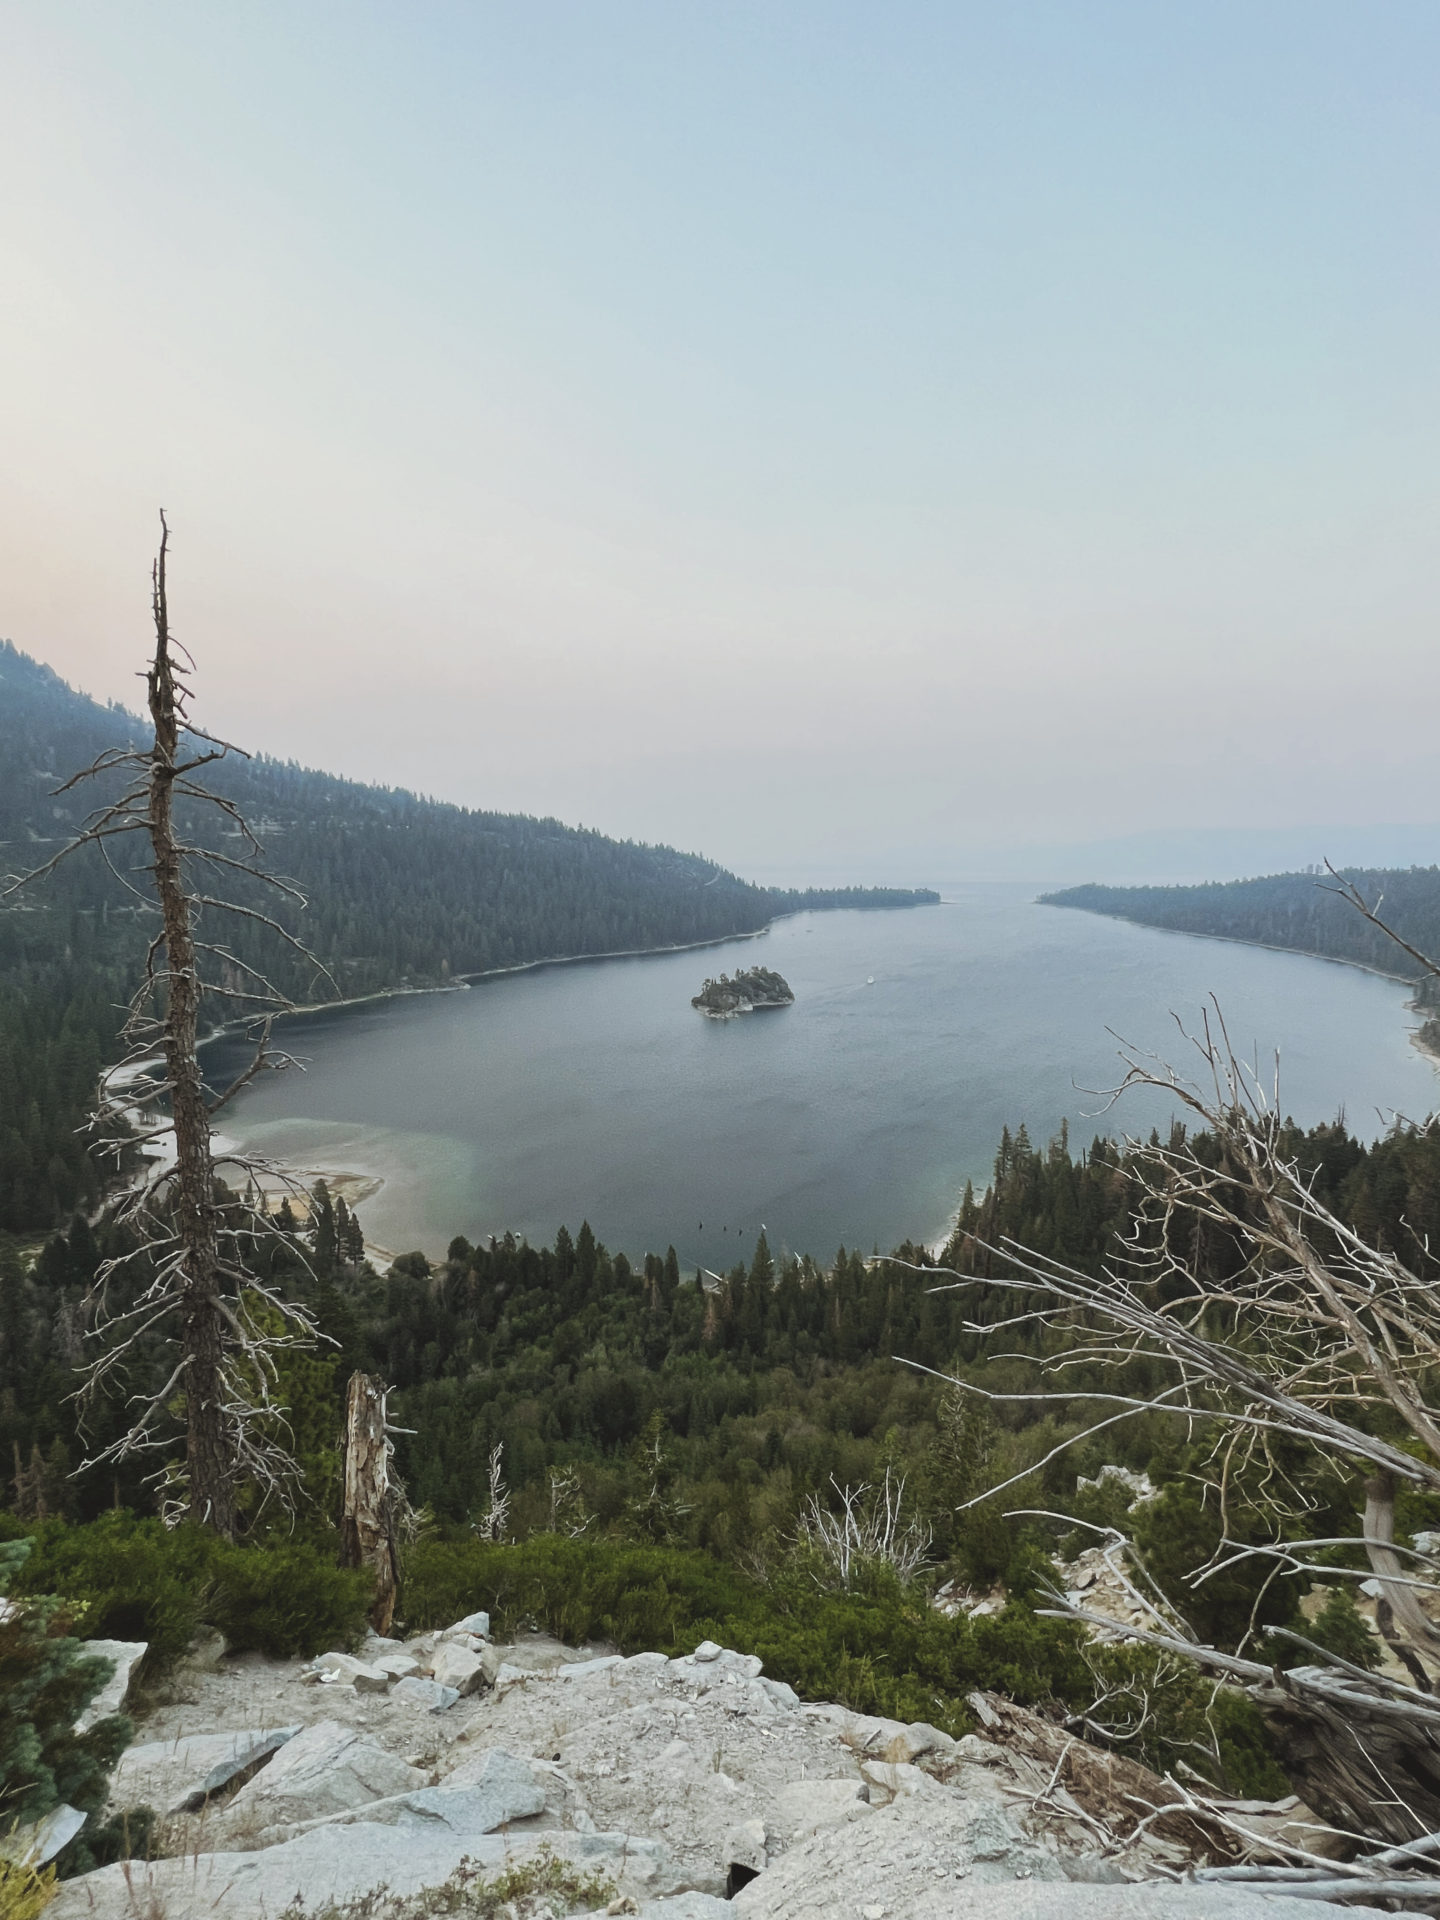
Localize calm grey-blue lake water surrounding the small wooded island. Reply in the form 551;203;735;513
214;885;1440;1267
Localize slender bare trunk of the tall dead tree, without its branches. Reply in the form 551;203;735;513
146;518;236;1538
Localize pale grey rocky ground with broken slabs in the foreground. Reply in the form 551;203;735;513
50;1615;1405;1920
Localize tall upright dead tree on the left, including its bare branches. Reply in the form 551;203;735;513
6;513;328;1536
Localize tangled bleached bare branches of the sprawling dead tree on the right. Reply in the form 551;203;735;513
887;913;1440;1873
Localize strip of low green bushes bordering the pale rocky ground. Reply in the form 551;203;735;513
0;1513;1279;1791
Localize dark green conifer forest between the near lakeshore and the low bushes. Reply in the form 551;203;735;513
11;1123;1440;1551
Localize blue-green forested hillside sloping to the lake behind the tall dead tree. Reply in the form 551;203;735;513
0;643;937;1229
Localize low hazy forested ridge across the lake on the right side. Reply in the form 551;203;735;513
1041;866;1440;1044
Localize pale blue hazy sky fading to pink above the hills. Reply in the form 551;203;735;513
0;0;1440;877
